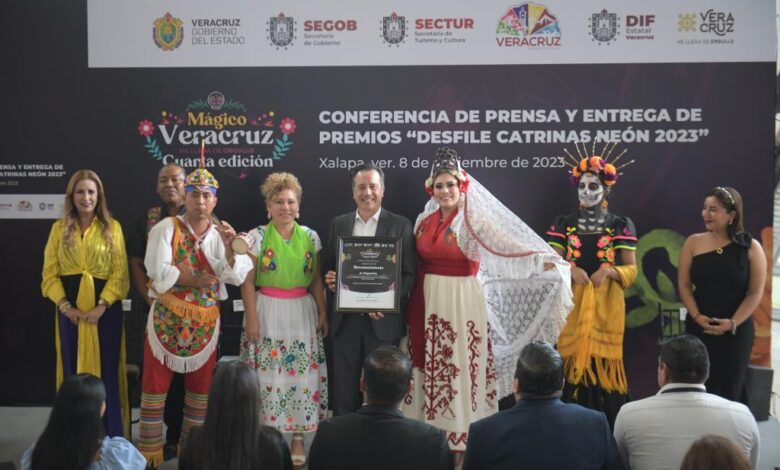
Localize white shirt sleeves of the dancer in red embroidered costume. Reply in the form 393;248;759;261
144;215;252;300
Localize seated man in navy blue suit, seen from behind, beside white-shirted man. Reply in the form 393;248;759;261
463;341;623;470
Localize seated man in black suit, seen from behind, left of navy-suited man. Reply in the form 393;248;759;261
309;346;452;470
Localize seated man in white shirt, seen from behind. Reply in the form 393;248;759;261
615;335;759;470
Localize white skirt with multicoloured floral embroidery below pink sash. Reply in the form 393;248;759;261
241;292;328;432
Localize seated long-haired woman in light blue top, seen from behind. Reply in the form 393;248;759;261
21;374;146;470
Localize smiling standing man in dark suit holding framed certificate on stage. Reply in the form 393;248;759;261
322;165;417;416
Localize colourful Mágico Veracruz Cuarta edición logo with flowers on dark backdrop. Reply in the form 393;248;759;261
138;91;297;174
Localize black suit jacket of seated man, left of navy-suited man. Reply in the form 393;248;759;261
309;405;452;470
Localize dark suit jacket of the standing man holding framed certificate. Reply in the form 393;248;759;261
322;208;417;343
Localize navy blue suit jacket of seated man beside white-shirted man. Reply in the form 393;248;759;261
463;398;623;470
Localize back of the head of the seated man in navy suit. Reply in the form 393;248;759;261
515;341;563;398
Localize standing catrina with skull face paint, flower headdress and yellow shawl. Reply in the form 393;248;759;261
547;143;637;426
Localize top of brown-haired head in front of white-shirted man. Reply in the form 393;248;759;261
680;434;750;470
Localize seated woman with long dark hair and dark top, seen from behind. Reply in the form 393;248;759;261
179;361;293;470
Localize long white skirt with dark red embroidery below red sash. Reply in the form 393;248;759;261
402;274;498;451
